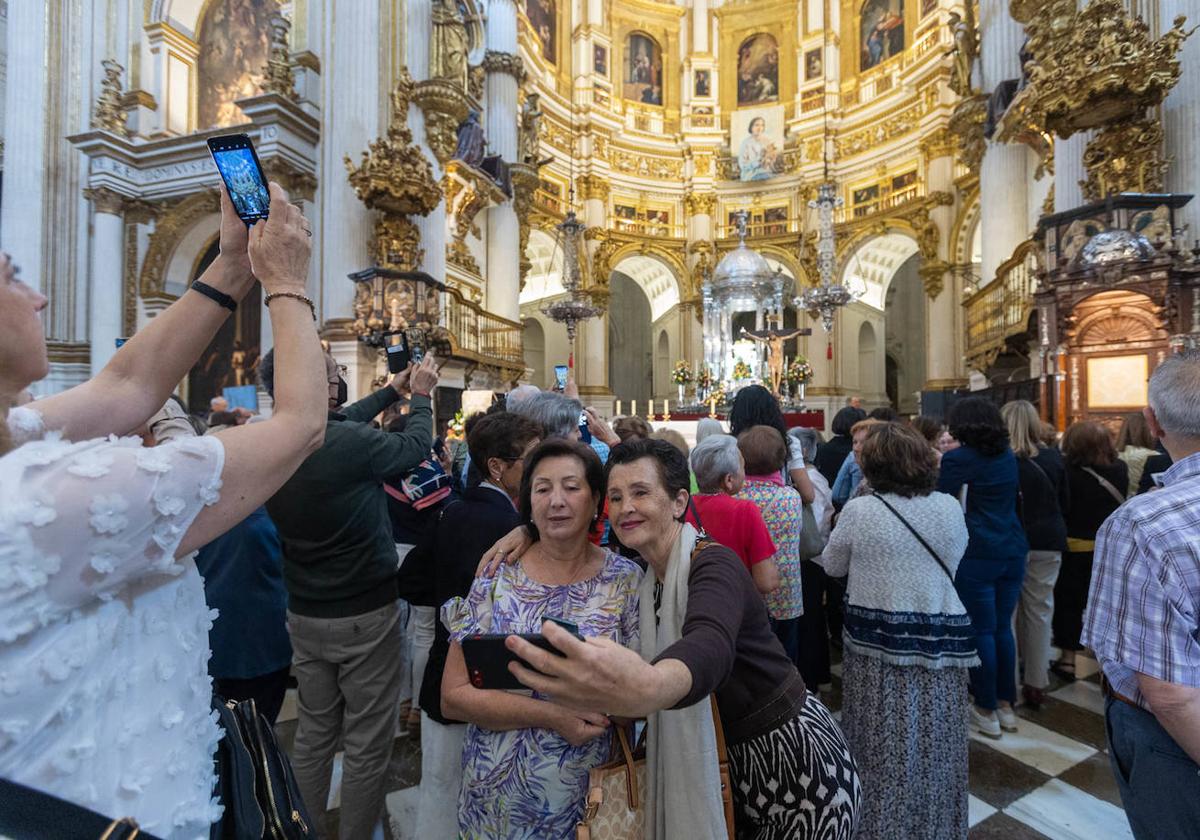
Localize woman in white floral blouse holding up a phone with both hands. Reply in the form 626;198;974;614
0;184;328;838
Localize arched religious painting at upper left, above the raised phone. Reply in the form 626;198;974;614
197;0;280;128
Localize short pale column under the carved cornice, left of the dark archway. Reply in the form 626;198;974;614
85;187;127;376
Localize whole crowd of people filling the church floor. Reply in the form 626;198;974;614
0;178;1200;840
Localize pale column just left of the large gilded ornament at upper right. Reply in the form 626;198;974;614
979;0;1032;284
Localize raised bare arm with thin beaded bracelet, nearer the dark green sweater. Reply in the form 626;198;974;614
175;184;329;554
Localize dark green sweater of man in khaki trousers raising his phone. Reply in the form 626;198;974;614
266;386;433;618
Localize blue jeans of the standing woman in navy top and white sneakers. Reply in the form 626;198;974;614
954;554;1025;709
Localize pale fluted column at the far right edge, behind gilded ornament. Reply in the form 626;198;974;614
1158;0;1200;236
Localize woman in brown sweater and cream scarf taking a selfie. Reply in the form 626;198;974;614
509;440;860;840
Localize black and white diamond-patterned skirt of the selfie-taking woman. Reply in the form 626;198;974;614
730;694;862;840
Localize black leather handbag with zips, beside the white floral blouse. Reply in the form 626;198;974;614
210;696;317;840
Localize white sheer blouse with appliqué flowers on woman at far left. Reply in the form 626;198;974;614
0;409;224;838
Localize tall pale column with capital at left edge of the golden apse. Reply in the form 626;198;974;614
484;0;521;320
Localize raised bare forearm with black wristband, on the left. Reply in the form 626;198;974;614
37;186;258;440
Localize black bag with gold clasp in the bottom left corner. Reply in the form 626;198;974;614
0;779;158;840
